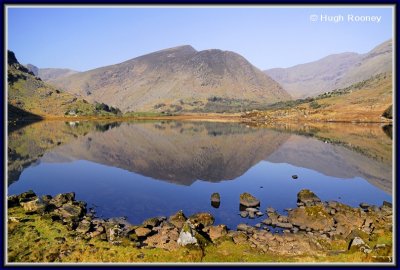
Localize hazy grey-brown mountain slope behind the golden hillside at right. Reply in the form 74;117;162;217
264;39;393;98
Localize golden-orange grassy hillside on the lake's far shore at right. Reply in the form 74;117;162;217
243;73;393;122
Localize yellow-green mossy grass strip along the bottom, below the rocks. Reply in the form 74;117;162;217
7;207;392;263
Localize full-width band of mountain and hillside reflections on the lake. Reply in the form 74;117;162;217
8;121;392;193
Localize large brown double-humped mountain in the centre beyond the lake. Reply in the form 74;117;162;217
52;45;291;112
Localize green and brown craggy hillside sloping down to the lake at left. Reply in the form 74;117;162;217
7;51;115;119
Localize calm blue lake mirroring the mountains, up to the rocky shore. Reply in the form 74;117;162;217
8;121;393;229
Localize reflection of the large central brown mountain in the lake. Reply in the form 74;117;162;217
41;122;290;185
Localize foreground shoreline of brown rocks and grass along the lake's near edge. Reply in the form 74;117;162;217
7;190;393;262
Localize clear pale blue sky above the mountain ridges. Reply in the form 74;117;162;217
7;6;393;71
